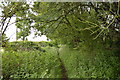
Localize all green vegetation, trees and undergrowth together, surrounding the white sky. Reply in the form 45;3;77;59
0;1;120;80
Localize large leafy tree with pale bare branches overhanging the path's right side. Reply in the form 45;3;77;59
28;2;120;45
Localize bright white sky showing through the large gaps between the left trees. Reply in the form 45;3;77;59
5;17;47;42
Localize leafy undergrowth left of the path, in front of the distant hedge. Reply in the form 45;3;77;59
3;50;60;79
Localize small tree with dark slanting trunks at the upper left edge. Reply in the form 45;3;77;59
0;2;29;41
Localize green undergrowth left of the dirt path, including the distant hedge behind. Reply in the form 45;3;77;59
2;42;61;79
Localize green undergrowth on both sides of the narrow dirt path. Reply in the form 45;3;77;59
2;42;120;80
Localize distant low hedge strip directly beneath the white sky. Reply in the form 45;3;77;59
7;41;56;52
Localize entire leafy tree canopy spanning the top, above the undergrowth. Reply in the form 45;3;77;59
1;2;120;46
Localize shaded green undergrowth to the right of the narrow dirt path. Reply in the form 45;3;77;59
60;46;120;78
